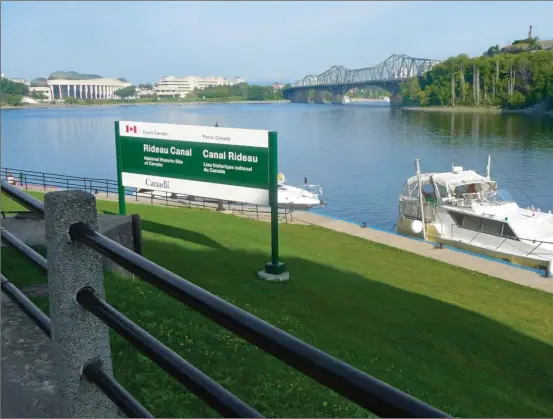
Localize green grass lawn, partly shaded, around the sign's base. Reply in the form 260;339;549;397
2;194;553;417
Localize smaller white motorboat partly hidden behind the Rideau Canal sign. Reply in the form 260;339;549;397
132;173;326;210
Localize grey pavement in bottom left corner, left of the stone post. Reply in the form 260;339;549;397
0;290;59;418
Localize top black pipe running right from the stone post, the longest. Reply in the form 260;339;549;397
69;223;447;418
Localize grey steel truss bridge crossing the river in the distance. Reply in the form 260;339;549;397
283;54;441;103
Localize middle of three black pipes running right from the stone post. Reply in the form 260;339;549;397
77;288;262;418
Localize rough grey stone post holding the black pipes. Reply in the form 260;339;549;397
44;190;121;418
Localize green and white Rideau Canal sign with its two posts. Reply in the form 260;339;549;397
115;121;288;281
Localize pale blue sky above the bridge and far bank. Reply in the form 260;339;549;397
0;1;553;84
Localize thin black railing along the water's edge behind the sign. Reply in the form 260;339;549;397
0;167;294;222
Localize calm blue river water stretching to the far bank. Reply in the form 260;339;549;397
1;103;553;229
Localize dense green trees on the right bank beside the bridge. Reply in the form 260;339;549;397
400;47;553;109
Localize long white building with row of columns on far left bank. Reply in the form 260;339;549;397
48;78;131;99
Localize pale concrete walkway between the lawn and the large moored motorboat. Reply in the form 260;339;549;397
294;211;553;293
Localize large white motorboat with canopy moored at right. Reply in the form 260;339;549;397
397;157;553;275
